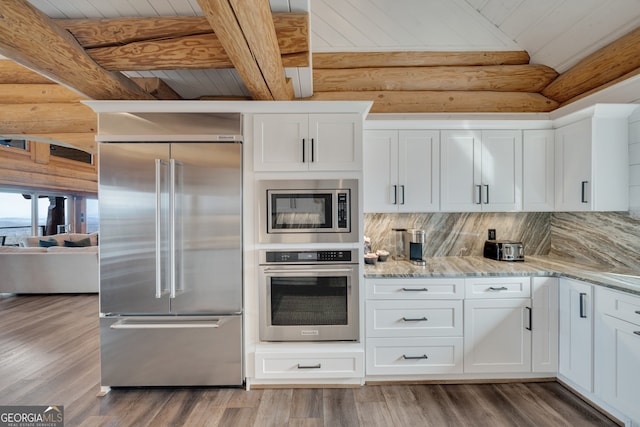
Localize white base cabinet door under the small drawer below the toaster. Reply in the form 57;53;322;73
464;298;531;373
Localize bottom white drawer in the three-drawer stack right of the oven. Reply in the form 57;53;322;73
366;337;463;375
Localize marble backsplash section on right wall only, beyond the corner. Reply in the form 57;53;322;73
550;212;640;271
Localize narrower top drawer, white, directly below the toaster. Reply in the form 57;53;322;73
465;277;531;299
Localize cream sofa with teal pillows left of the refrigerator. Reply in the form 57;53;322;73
0;233;99;294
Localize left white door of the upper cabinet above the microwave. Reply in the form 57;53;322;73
253;114;310;171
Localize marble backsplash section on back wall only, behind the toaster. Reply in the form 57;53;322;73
364;212;551;257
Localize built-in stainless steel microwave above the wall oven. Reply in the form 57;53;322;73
258;179;360;243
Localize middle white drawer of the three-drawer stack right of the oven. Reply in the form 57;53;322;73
366;300;462;337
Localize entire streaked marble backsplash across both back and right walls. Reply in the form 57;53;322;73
364;212;640;270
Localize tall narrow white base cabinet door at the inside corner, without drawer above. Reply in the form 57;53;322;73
531;277;558;373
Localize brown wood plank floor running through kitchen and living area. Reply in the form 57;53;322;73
0;295;615;427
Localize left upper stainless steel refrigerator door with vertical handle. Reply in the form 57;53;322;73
98;143;170;313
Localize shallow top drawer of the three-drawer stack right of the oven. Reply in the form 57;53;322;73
365;278;464;300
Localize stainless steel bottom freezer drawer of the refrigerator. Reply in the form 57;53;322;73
100;316;243;387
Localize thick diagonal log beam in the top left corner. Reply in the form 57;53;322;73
0;0;153;99
